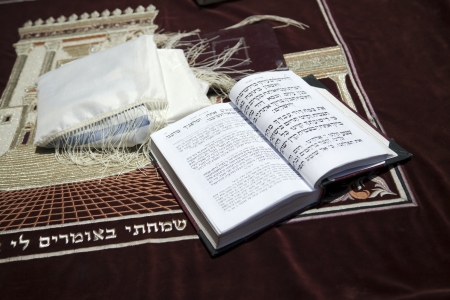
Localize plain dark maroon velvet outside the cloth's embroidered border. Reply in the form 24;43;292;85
0;0;450;299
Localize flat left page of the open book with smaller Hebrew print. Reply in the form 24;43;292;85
152;103;312;234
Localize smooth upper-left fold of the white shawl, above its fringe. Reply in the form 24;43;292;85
34;36;168;146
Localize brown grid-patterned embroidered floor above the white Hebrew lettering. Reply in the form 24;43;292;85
0;165;179;232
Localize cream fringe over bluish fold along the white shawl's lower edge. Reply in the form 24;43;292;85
51;102;168;170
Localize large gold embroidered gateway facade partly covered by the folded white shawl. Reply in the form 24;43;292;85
0;5;158;191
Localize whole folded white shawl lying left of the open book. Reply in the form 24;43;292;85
34;35;211;147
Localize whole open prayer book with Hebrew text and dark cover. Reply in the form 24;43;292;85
151;71;410;255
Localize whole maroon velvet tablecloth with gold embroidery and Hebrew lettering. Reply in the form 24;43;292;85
0;0;450;299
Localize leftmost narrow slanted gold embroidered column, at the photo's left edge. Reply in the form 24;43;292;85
0;43;34;108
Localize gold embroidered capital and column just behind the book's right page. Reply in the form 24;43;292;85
284;46;356;110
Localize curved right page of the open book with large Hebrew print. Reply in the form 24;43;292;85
230;71;391;186
